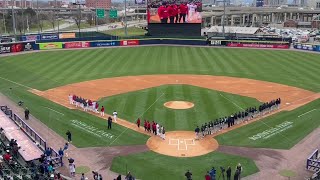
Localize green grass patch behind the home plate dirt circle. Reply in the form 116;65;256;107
111;151;258;180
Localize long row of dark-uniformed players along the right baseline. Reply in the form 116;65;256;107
195;98;281;139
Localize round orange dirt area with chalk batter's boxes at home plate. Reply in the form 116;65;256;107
147;131;219;157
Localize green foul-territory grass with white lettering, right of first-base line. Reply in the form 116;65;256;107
215;99;320;149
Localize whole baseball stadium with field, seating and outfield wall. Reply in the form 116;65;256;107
0;6;320;180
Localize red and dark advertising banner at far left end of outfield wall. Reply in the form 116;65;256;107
0;42;33;54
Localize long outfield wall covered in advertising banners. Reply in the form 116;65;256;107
0;38;320;54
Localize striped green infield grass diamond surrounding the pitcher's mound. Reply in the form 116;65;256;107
100;85;261;131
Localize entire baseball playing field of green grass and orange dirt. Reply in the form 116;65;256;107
0;46;320;180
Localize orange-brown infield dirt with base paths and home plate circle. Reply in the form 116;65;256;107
31;75;320;157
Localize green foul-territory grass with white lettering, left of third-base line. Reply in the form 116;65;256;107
0;83;149;147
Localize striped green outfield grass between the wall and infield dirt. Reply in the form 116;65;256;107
0;46;320;92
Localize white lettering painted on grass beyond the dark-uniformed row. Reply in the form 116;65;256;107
249;121;293;141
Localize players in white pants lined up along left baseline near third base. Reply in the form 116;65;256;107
68;94;118;122
